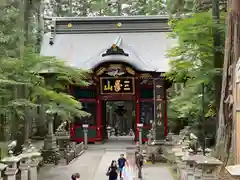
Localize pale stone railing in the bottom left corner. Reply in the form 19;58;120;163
0;146;42;180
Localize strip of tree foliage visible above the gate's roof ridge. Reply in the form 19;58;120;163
45;0;166;17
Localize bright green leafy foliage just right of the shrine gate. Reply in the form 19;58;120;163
166;13;224;124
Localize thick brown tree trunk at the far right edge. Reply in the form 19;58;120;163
216;0;240;165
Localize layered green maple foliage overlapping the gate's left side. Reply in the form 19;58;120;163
0;49;89;141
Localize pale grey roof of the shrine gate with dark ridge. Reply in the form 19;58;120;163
41;16;173;72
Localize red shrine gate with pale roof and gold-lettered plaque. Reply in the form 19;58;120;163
41;16;173;142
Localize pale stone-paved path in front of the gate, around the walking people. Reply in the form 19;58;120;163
39;136;173;180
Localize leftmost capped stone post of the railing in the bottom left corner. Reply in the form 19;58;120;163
2;156;21;180
